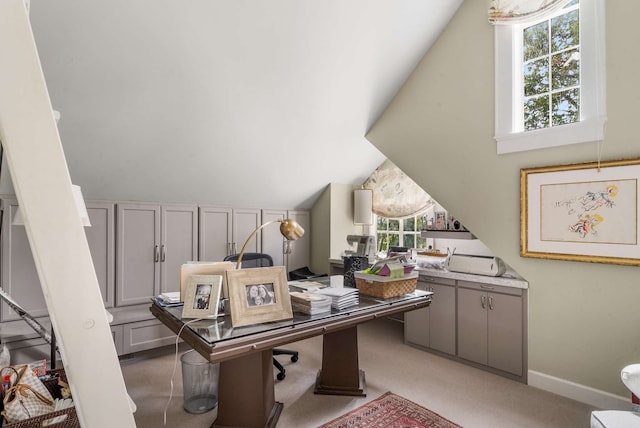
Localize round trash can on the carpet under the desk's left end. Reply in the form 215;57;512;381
180;350;220;413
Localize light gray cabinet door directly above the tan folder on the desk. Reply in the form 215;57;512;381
198;206;234;262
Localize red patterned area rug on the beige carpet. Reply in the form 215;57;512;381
319;392;462;428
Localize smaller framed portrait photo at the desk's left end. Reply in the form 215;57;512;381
182;275;222;318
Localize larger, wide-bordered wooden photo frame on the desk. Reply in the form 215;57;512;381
227;266;293;327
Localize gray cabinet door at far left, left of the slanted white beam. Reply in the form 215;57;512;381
2;199;48;321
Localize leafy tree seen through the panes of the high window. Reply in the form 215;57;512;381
522;0;580;131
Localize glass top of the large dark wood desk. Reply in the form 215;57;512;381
153;275;433;345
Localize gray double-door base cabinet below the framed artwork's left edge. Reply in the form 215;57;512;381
458;281;523;376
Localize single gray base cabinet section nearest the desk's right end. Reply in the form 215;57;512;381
405;276;456;355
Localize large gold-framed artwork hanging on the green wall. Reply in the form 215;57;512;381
520;159;640;265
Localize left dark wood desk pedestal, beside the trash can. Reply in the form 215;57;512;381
211;349;282;428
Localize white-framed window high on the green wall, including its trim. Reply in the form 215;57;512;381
495;0;606;154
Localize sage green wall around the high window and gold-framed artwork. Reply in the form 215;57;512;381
367;0;640;397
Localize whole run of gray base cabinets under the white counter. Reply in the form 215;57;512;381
404;272;527;383
